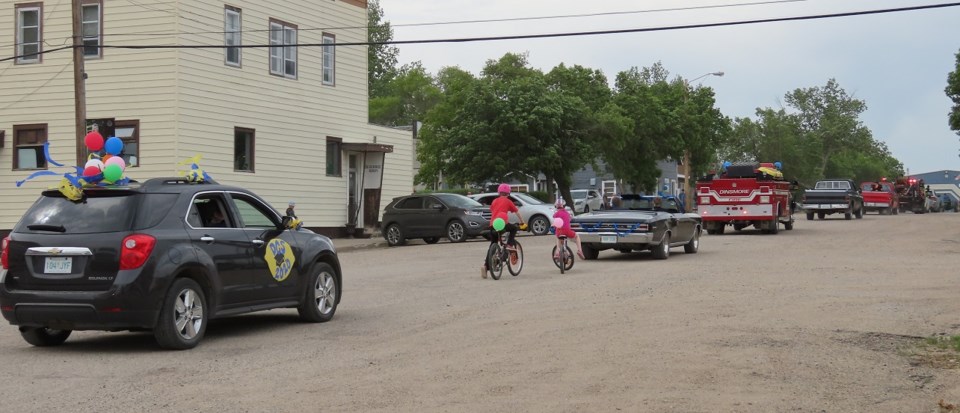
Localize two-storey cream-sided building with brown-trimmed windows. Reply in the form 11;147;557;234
0;0;413;235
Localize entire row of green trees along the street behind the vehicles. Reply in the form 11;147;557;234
368;0;916;199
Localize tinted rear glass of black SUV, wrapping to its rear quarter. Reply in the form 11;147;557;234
15;191;176;234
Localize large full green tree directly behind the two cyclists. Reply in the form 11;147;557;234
417;53;605;204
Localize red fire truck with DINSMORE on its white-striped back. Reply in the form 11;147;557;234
696;163;796;234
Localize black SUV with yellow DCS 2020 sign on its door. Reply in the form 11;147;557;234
0;178;342;349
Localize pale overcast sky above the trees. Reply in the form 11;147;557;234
380;0;960;173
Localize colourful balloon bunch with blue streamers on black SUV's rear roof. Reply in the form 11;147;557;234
17;131;130;201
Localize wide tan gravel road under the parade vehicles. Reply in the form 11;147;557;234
0;213;960;413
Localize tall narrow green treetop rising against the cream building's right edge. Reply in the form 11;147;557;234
367;0;400;97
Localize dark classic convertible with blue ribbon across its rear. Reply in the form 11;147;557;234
570;195;703;260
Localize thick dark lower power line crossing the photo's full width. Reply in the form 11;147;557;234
0;2;960;62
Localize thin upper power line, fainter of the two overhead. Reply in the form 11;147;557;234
104;0;807;37
